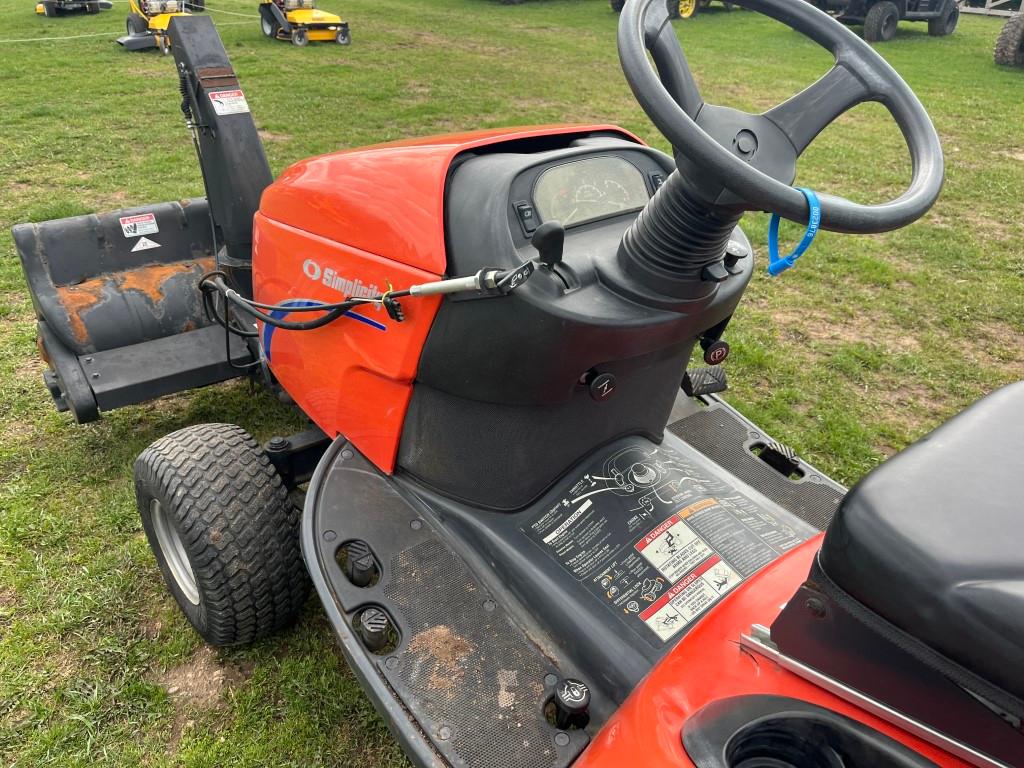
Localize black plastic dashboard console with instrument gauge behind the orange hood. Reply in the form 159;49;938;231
397;131;753;510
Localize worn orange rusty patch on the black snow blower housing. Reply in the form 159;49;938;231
56;256;216;344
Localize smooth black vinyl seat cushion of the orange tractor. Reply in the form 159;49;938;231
819;382;1024;699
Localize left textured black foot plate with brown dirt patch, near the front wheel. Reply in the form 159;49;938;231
303;442;588;768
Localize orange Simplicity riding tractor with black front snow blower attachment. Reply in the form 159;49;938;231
14;0;1024;768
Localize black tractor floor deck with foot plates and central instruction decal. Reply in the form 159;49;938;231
302;397;843;768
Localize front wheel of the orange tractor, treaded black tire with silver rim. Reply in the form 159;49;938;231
135;424;309;646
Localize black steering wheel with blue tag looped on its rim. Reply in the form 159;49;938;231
618;0;943;232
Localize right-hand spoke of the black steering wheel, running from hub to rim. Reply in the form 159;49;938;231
763;62;876;155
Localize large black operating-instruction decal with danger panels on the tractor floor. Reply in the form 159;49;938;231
522;438;817;643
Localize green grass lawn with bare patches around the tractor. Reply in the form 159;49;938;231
0;0;1024;768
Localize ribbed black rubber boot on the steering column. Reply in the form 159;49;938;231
618;171;742;300
